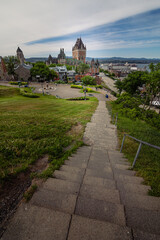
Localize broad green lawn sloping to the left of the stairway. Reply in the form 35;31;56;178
0;87;97;181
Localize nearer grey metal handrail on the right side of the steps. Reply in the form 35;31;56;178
120;134;160;168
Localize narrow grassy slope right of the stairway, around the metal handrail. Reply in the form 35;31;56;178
109;101;160;197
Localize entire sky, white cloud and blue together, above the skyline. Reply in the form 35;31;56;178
0;0;160;58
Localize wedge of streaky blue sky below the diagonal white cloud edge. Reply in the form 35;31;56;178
26;9;160;58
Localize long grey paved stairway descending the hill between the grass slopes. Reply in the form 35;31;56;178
2;100;160;240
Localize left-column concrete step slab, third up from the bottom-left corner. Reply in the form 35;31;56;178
42;178;80;195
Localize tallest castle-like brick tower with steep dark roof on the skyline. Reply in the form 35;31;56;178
72;38;86;63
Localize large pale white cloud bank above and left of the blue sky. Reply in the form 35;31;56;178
0;0;160;56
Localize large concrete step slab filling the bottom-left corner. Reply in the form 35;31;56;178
1;204;71;240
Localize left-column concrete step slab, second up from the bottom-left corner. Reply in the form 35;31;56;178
30;188;77;214
